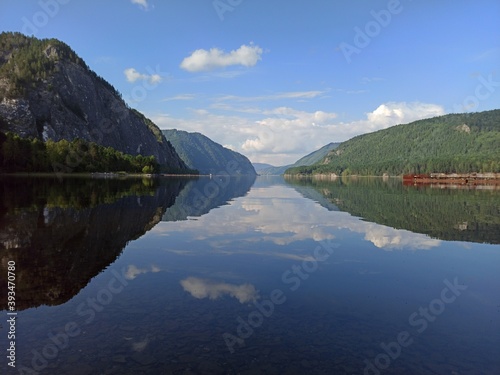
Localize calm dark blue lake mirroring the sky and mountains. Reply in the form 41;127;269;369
0;176;500;375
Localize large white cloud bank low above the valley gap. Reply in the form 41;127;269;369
152;100;445;165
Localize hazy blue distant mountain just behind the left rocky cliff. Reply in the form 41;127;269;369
162;129;256;175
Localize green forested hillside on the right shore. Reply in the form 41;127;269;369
286;109;500;176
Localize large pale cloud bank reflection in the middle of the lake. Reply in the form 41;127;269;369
152;185;441;253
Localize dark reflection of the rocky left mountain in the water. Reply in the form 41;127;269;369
0;178;187;310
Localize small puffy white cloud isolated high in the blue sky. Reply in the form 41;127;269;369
180;45;263;72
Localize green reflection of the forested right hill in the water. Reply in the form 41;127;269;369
287;178;500;244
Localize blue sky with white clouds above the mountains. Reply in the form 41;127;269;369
0;0;500;165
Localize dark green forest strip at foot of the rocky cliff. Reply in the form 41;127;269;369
0;132;160;173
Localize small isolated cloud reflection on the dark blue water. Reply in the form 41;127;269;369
180;277;259;303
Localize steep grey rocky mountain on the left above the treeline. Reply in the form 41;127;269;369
0;33;186;171
